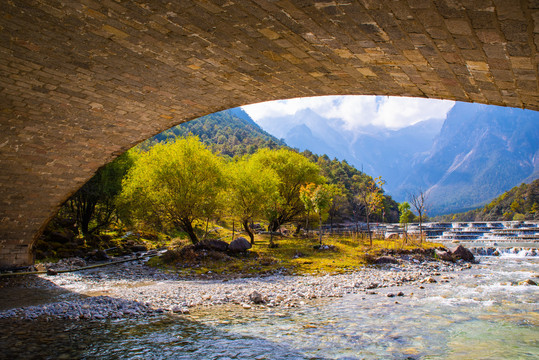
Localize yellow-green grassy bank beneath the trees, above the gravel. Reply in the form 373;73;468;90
150;235;440;276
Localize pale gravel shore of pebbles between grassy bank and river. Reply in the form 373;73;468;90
0;259;470;320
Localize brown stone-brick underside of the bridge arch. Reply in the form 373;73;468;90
0;0;539;267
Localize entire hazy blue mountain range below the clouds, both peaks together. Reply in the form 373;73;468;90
253;103;539;215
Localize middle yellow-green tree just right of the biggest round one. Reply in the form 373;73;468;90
227;157;279;244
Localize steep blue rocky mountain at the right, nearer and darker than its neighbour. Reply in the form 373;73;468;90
402;103;539;215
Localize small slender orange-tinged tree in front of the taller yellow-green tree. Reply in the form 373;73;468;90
300;183;338;245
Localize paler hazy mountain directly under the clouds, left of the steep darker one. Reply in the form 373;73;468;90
280;110;443;183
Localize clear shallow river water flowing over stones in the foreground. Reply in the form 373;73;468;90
0;256;539;359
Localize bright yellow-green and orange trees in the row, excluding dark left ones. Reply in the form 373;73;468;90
117;137;398;243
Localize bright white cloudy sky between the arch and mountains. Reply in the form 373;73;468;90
242;95;455;131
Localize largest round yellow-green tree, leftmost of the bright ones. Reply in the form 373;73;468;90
121;137;225;243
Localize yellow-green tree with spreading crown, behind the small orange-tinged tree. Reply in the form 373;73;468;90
252;149;325;232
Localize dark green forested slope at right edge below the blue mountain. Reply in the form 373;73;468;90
437;179;539;221
